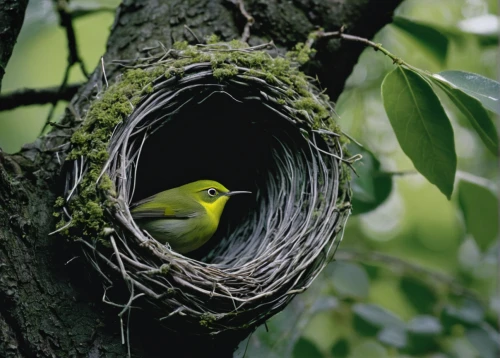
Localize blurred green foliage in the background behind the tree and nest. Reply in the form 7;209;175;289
0;0;500;358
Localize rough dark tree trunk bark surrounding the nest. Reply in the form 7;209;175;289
0;0;400;357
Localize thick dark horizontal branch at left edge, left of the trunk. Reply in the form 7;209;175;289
0;83;82;111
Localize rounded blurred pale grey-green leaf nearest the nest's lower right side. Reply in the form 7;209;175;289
332;261;370;299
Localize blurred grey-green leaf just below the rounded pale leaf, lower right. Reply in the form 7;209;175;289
352;303;405;336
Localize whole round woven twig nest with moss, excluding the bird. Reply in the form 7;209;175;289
58;41;350;334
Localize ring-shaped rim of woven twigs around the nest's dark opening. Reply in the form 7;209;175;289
58;42;350;334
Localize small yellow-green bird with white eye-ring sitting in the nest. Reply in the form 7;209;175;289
131;180;251;254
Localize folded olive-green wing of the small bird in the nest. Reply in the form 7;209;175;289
131;193;203;219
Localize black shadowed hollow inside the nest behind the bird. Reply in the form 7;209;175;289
132;93;306;263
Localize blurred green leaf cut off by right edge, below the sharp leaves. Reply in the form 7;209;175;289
458;174;498;250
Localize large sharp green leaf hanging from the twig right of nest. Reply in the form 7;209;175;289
382;66;457;199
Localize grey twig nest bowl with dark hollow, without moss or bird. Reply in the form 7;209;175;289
61;44;350;334
